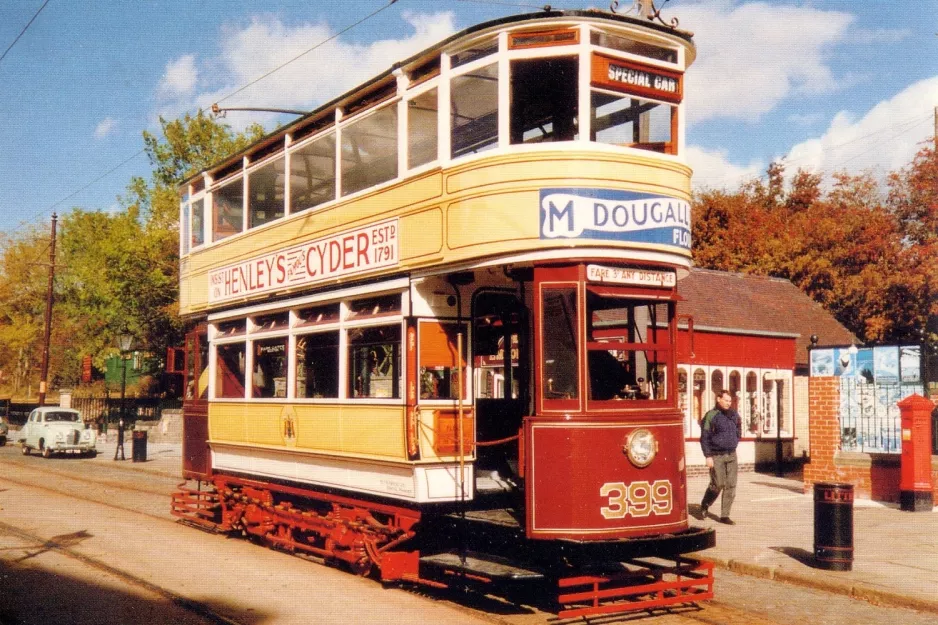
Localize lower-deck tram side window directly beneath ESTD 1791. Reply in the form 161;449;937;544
348;324;401;398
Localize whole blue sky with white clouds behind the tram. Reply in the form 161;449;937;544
0;0;938;234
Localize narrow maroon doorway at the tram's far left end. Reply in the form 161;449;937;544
182;324;212;479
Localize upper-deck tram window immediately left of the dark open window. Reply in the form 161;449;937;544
450;63;498;158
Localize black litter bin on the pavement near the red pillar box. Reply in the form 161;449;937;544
814;482;853;571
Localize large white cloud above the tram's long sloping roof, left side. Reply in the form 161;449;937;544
161;12;456;128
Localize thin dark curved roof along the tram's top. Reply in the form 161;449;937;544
180;5;694;186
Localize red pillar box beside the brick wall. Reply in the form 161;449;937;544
898;395;935;512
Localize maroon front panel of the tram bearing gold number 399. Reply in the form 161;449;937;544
525;417;688;540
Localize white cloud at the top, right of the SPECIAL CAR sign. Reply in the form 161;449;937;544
680;0;854;124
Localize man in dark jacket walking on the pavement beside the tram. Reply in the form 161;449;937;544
700;390;742;525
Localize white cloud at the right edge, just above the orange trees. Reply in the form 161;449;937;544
785;76;938;176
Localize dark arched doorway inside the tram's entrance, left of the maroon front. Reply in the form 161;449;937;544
472;289;530;477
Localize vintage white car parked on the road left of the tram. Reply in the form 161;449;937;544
17;406;96;458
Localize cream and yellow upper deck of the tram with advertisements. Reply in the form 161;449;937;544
180;11;695;316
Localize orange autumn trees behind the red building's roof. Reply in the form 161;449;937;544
693;147;938;344
